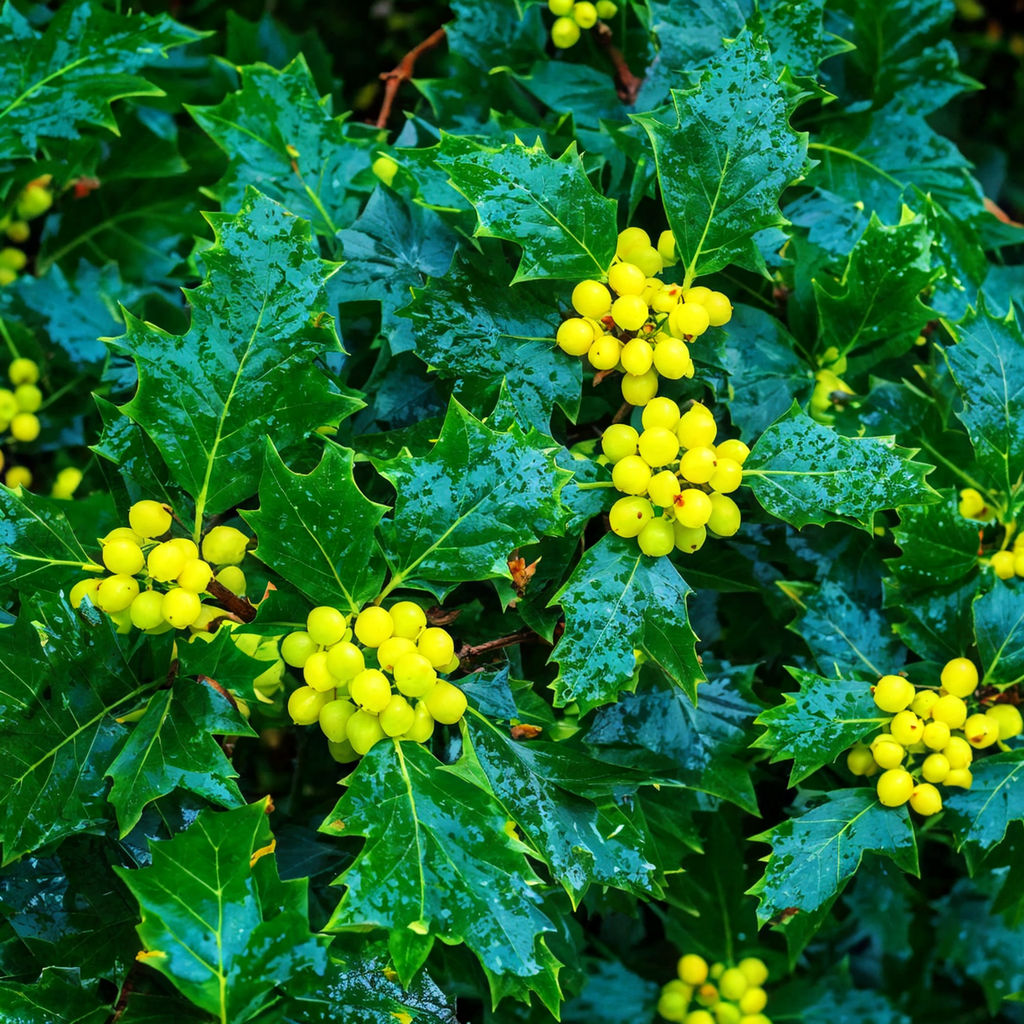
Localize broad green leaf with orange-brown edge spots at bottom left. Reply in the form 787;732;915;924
118;800;327;1024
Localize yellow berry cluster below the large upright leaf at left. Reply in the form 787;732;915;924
70;501;249;634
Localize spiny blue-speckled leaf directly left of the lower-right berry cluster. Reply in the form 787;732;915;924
754;669;891;786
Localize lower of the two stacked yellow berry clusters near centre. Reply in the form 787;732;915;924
601;397;750;557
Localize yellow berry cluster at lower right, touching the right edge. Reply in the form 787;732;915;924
846;657;1024;816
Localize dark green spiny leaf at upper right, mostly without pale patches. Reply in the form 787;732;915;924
814;210;941;366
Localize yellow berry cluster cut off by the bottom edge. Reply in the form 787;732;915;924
657;953;771;1024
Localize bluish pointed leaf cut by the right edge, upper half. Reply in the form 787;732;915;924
945;306;1024;494
